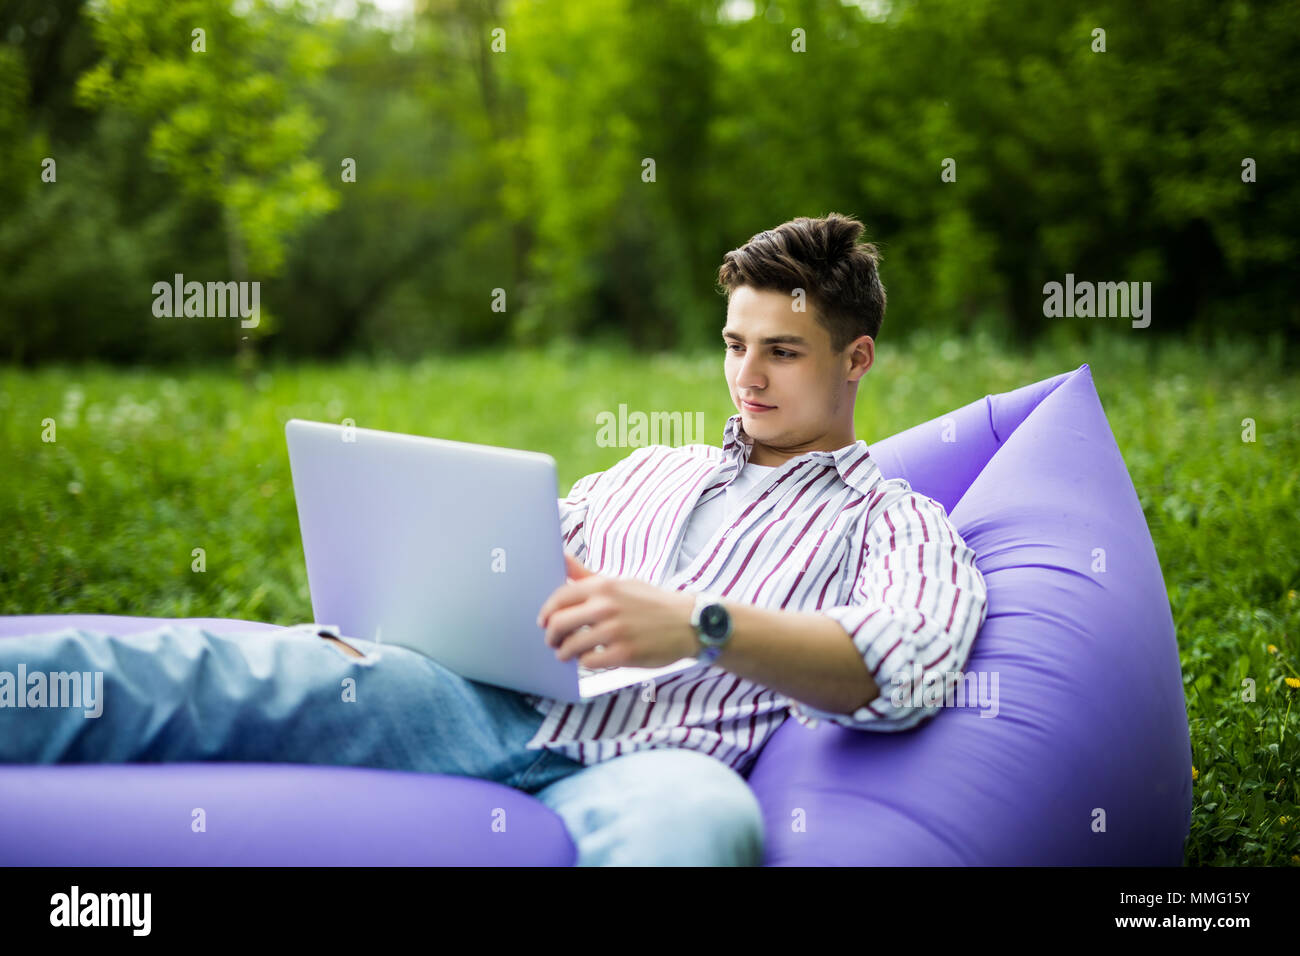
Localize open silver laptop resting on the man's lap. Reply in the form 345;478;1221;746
285;419;699;701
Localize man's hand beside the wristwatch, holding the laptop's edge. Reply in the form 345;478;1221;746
537;553;699;667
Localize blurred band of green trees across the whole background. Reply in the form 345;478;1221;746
0;0;1300;362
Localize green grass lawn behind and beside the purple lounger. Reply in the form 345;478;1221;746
0;323;1300;865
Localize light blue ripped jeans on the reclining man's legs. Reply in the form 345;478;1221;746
0;624;763;866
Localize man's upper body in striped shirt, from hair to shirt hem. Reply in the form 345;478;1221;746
512;213;987;816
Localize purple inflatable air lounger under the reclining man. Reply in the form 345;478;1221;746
0;364;1192;866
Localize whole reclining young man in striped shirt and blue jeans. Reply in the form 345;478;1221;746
0;215;987;865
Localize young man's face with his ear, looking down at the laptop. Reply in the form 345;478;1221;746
723;286;875;464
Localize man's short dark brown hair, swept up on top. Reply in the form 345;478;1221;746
718;212;885;352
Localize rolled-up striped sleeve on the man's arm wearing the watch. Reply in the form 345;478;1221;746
790;489;988;732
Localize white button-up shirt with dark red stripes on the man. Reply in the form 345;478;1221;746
527;414;988;775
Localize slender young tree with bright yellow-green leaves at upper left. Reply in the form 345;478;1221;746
79;0;338;376
